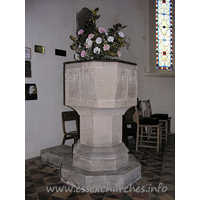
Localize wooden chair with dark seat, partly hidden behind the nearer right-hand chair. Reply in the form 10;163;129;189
143;99;171;143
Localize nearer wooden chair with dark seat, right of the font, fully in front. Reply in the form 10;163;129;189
133;101;162;153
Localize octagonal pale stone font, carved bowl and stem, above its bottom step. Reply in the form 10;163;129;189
64;60;140;190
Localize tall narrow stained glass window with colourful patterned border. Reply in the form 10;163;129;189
156;0;173;70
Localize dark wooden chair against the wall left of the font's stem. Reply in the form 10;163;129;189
62;111;80;145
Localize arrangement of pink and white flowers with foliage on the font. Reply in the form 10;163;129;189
70;8;127;60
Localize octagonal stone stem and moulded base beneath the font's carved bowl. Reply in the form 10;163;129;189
73;107;129;171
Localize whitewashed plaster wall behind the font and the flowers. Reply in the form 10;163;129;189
25;0;175;159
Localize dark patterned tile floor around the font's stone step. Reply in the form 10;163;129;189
25;134;175;200
